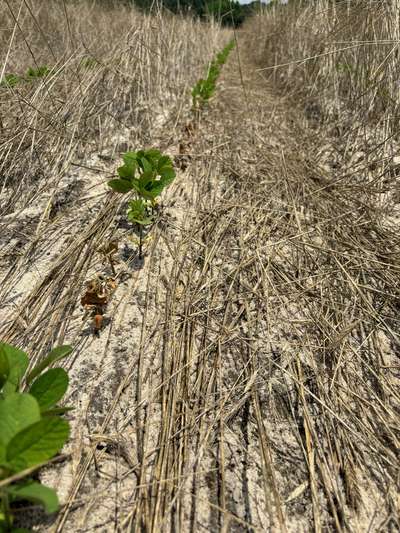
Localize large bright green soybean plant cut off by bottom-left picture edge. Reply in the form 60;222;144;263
0;342;72;533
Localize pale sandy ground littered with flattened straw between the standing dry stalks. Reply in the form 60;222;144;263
0;2;400;533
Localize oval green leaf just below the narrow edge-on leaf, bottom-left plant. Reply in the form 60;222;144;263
29;368;69;411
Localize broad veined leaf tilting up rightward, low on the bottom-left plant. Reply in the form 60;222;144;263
6;416;69;472
